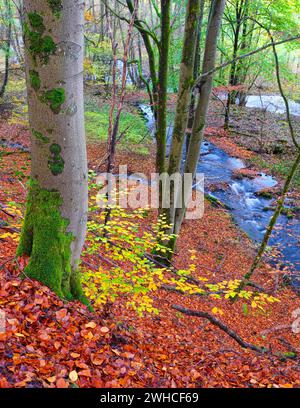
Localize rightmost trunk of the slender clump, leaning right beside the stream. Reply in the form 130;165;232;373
174;0;226;234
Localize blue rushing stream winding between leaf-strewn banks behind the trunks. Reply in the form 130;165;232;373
139;104;300;291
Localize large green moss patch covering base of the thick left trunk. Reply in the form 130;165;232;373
17;181;87;303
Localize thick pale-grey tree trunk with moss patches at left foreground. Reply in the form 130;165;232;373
17;0;88;300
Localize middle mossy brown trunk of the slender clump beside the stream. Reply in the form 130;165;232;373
168;0;200;230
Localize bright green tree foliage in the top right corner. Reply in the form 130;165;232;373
215;0;300;87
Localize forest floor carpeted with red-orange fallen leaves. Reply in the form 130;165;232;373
0;86;300;388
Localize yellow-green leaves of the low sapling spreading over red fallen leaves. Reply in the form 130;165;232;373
82;180;277;315
